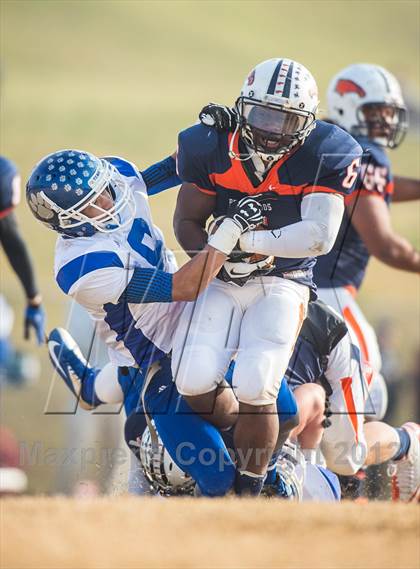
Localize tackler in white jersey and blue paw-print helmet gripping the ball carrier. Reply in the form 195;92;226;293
26;150;276;496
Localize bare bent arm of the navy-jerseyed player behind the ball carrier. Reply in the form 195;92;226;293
351;194;420;273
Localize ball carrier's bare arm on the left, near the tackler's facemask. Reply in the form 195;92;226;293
173;183;216;257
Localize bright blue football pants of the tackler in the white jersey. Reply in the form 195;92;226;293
119;357;297;496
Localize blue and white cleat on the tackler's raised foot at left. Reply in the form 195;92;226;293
48;328;101;411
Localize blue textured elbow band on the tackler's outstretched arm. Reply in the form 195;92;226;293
118;268;173;304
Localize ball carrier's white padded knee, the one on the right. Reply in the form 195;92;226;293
232;352;281;406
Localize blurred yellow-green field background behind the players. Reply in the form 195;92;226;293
0;0;420;492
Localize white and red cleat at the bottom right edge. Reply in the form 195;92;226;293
391;423;420;502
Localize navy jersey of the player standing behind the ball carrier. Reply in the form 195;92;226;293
314;138;394;289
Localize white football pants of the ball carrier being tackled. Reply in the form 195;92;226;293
172;277;309;405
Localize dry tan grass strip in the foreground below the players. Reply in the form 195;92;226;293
0;497;420;569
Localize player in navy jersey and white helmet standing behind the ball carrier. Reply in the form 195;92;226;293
200;64;420;498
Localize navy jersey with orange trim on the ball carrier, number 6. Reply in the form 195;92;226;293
178;121;362;286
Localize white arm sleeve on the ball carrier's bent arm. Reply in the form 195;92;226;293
240;193;344;258
